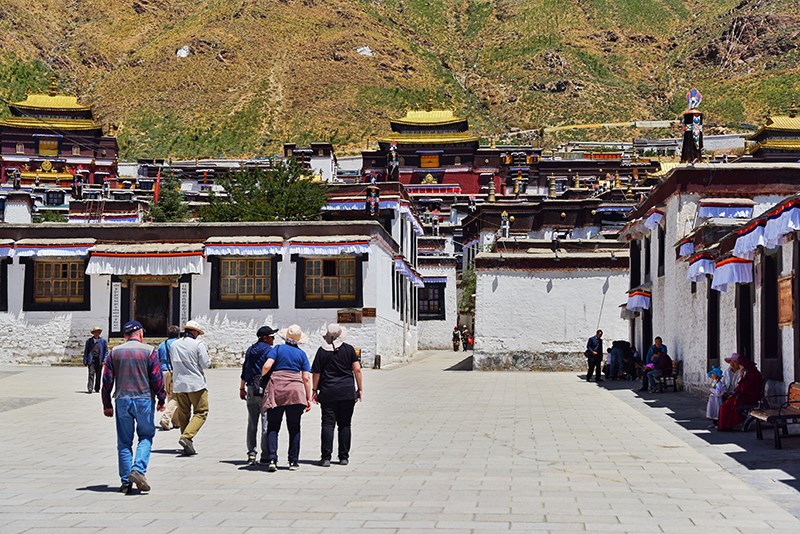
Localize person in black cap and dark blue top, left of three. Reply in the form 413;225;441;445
239;326;277;465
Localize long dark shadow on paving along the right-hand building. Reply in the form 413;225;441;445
578;374;800;492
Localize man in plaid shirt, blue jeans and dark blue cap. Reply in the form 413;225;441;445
101;321;166;494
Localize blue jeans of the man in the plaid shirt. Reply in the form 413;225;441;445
114;397;156;484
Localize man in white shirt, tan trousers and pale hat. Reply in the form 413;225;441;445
170;321;211;456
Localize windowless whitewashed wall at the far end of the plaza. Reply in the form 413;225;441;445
475;270;628;370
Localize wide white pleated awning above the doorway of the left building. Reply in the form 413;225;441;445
86;243;204;276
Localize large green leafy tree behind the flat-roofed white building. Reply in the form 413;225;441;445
200;161;328;222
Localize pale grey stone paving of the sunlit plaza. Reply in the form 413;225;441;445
0;352;800;534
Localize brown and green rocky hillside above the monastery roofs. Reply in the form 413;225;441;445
0;0;800;157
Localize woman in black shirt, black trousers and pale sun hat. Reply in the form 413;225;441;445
311;323;361;467
